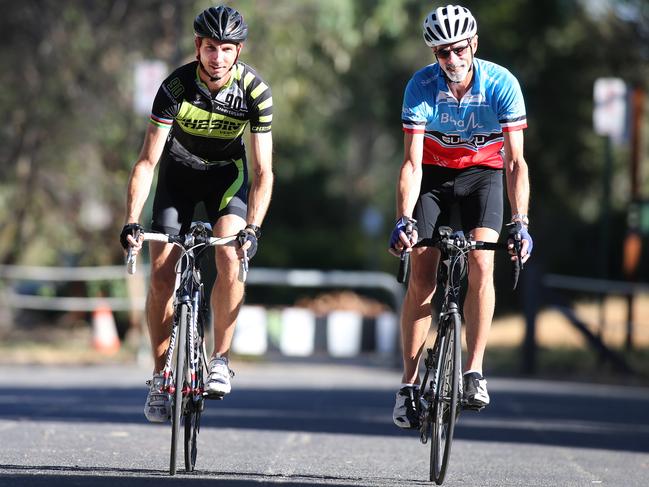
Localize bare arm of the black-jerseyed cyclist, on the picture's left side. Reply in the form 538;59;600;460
125;124;169;223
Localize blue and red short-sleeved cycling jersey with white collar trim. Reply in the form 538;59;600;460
401;58;527;169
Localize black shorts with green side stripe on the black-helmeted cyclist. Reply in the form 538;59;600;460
151;155;248;235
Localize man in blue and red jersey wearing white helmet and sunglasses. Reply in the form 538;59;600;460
389;5;532;428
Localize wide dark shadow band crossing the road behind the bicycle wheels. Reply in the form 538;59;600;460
0;387;649;454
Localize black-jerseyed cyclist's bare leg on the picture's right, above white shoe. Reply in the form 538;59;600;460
211;215;246;357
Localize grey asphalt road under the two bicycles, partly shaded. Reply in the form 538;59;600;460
0;362;649;487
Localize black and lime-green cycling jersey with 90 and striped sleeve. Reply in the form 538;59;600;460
151;61;273;165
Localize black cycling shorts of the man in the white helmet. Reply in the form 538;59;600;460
413;164;504;239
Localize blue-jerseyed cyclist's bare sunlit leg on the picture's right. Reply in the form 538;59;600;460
464;228;498;373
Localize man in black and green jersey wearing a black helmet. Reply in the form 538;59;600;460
120;6;273;422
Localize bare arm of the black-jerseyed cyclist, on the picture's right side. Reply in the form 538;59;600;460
248;132;274;226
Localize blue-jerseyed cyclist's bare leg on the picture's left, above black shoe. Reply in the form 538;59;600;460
401;247;439;384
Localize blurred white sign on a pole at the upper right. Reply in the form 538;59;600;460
593;78;627;143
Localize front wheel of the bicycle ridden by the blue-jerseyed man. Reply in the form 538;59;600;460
430;313;462;485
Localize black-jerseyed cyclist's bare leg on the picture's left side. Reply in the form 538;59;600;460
146;242;179;372
